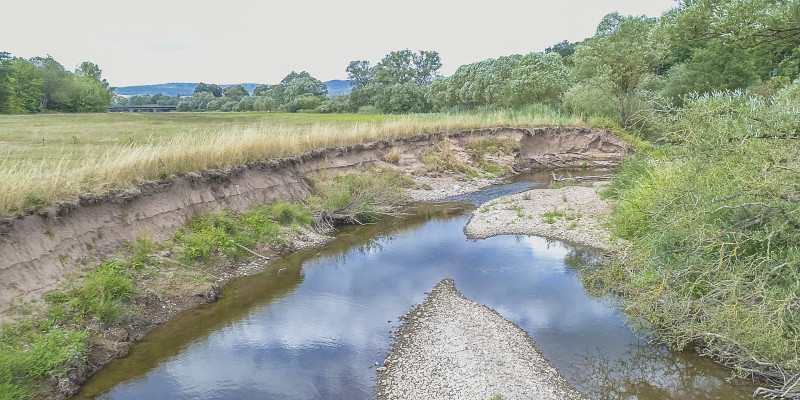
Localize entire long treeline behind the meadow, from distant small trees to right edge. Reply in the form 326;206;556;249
136;0;800;126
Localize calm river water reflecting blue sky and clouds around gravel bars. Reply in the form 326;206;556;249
78;176;753;400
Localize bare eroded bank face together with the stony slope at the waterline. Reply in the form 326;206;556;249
0;129;627;398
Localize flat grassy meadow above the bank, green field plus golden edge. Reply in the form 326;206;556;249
0;107;584;214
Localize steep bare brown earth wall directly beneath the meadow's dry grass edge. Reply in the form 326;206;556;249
0;128;630;319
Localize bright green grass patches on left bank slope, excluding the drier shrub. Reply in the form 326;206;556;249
0;193;324;400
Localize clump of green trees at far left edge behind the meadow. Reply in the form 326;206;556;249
0;52;113;114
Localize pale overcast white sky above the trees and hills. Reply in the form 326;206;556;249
0;0;674;86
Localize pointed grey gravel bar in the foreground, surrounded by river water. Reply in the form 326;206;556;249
378;279;584;400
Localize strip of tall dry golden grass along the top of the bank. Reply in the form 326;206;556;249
0;108;584;214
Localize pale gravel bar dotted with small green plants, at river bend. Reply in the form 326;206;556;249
464;185;618;251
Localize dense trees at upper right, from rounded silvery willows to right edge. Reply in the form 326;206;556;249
428;0;800;126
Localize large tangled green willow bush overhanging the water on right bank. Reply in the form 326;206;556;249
588;88;800;378
